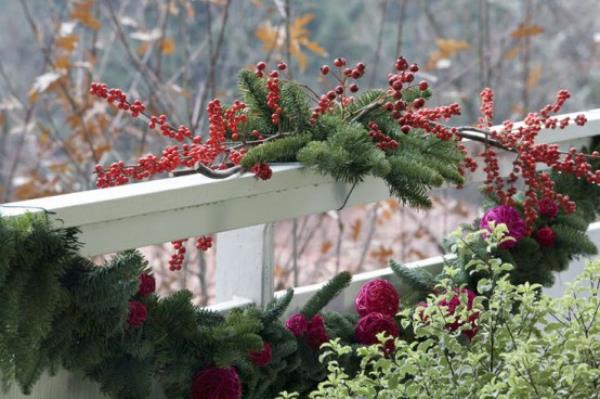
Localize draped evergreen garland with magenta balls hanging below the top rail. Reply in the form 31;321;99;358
0;138;600;398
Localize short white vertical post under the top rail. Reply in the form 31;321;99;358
216;224;273;305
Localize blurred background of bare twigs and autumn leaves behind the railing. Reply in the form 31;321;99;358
0;0;600;303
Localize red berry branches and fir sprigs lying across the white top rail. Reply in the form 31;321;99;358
90;57;600;269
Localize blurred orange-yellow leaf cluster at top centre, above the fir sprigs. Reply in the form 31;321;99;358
254;14;327;71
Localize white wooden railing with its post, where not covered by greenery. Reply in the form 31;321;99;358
0;109;600;398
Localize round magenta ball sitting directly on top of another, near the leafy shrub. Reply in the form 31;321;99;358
354;279;400;316
